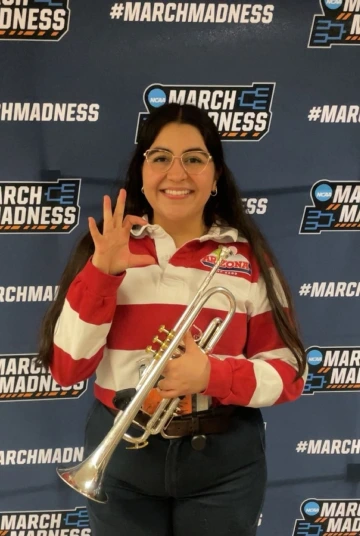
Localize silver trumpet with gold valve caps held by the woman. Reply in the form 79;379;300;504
56;247;236;503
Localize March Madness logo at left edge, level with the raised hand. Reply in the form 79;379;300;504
0;179;81;234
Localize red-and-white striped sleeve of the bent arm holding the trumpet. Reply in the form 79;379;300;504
203;260;307;408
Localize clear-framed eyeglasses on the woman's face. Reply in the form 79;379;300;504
144;149;212;175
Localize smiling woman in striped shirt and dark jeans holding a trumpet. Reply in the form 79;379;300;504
35;104;306;536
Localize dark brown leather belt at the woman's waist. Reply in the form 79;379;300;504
107;406;236;439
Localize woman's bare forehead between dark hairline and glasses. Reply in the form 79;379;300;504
151;123;206;152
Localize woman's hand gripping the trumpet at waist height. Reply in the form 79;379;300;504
157;331;210;398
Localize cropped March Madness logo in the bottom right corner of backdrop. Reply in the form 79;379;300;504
293;499;360;536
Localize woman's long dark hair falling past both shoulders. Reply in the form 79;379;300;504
36;103;306;378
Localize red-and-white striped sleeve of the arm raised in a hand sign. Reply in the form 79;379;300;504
50;258;125;387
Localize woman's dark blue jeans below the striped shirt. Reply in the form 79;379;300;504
85;401;266;536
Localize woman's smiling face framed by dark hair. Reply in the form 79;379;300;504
142;123;216;233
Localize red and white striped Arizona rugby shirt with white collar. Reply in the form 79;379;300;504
50;224;306;407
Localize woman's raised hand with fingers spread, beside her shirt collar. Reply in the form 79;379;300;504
88;189;155;275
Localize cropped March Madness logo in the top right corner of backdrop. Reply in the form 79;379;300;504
308;0;360;48
